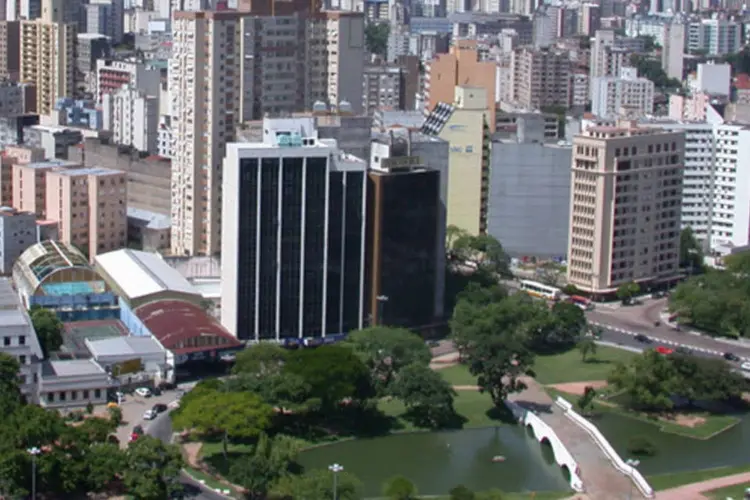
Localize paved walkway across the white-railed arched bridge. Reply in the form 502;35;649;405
508;377;648;500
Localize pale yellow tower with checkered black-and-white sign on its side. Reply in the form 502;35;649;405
422;86;491;234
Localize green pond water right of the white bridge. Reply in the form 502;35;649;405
593;413;750;475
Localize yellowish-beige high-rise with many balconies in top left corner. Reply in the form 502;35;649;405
19;0;76;114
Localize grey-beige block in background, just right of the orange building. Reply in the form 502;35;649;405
511;47;571;110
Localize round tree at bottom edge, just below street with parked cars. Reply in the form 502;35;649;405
122;436;183;500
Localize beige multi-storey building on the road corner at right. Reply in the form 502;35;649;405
568;120;685;294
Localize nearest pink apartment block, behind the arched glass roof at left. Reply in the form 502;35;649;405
46;168;127;259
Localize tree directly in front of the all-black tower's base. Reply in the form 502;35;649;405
343;326;432;396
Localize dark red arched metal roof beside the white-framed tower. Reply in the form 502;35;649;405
133;300;241;354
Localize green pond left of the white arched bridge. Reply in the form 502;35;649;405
299;425;569;497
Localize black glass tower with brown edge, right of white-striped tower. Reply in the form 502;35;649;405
366;133;445;329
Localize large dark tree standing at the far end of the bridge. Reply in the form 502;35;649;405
451;294;541;406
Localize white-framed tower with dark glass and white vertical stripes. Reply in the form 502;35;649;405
221;118;367;341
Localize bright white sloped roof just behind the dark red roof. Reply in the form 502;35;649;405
95;248;200;300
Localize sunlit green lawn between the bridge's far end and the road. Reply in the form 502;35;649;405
534;346;637;385
